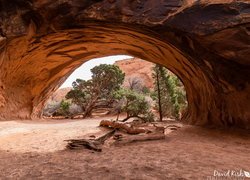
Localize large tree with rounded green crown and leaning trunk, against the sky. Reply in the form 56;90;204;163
66;64;125;117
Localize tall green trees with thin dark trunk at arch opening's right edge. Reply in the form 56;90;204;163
152;65;186;121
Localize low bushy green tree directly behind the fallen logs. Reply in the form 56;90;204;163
113;88;154;121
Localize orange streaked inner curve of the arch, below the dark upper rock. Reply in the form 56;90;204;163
0;22;248;127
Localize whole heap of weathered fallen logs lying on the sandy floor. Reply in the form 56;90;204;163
66;120;180;152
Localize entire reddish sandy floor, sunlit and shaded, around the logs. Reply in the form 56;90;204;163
0;119;250;180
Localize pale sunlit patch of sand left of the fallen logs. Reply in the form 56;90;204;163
0;118;101;152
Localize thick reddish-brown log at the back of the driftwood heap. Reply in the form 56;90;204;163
100;120;150;134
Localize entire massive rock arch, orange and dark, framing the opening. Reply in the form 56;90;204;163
0;0;250;128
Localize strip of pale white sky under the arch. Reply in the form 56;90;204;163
60;55;132;88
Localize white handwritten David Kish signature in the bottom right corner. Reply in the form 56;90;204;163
207;169;250;180
